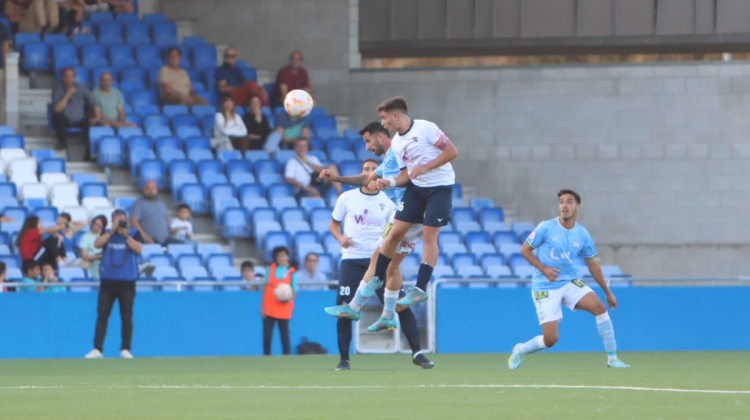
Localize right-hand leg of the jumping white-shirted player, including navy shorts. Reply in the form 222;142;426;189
396;185;453;306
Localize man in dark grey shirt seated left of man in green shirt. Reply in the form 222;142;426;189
52;67;101;150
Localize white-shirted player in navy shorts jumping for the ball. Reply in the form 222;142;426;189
368;96;458;329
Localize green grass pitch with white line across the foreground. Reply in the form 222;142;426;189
0;352;750;420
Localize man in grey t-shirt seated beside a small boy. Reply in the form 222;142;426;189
131;181;182;246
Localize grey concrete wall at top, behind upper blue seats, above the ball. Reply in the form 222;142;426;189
160;0;356;113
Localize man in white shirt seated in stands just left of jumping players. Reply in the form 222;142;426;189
284;139;341;199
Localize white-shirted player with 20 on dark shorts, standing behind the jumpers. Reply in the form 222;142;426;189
329;159;434;370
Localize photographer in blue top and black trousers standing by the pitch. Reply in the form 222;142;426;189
86;209;143;359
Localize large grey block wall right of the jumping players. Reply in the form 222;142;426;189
351;62;750;276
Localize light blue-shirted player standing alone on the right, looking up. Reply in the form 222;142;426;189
508;190;630;369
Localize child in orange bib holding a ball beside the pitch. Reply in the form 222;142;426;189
260;246;297;356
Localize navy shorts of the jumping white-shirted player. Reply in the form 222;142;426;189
396;184;453;227
